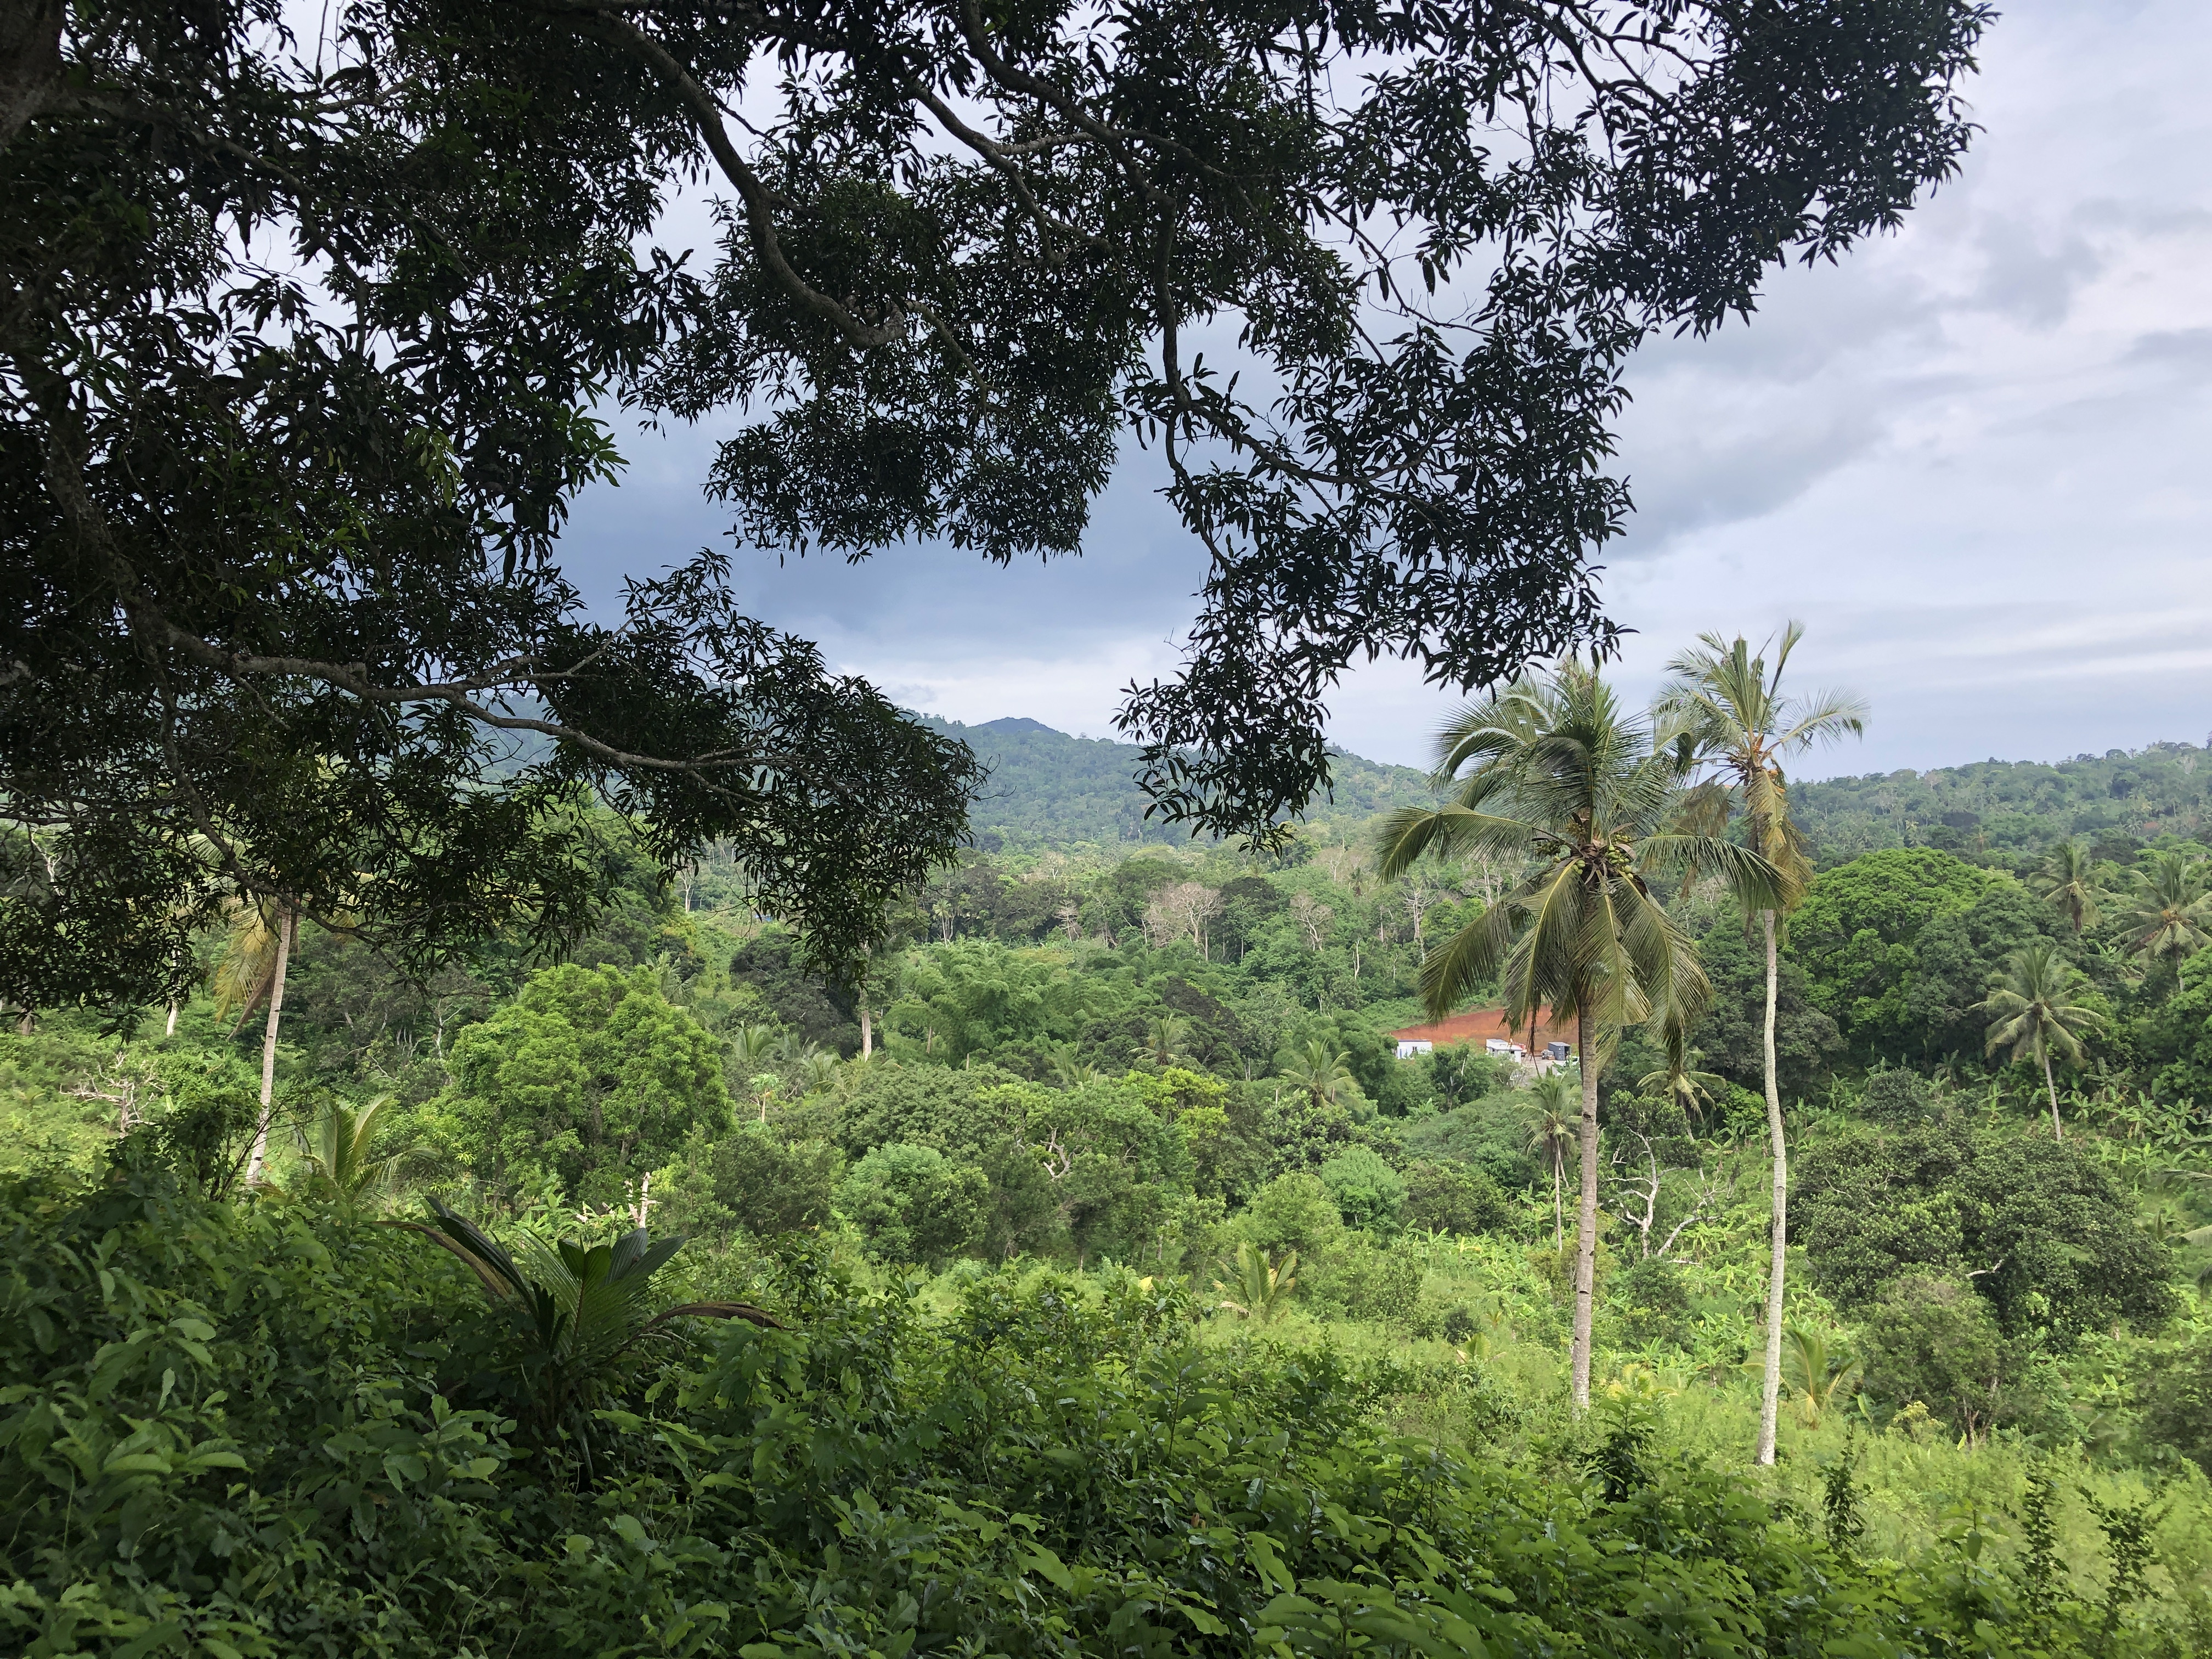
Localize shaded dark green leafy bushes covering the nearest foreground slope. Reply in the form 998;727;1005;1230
0;1159;2176;1659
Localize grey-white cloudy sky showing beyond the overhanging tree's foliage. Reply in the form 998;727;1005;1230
566;0;2212;774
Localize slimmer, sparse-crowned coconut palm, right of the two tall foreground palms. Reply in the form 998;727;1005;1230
1657;622;1867;1464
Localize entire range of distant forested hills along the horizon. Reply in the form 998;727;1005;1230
924;714;2212;865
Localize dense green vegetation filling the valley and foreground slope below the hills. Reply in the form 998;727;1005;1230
0;712;2212;1659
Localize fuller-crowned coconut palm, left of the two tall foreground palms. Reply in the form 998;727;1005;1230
1380;662;1785;1409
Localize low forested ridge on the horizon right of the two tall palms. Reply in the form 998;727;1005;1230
1790;743;2212;865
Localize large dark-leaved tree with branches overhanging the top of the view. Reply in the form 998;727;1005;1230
0;0;1989;1002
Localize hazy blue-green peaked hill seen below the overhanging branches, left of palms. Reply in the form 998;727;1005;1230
922;714;1431;851
